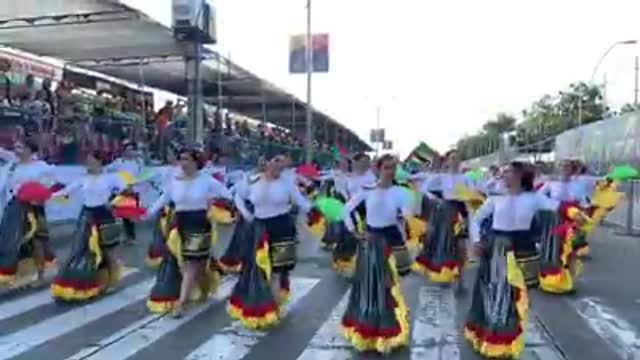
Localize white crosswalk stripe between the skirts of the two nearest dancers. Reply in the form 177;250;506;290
411;286;460;360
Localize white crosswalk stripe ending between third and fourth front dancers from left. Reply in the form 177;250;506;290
67;280;235;360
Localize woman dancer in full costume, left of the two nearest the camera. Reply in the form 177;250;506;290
342;155;412;354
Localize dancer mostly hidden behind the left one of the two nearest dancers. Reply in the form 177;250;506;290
332;153;376;277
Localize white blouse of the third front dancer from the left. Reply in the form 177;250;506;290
149;173;231;215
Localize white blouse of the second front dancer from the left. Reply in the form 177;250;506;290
53;173;127;207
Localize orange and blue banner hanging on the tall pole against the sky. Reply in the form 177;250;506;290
289;34;329;74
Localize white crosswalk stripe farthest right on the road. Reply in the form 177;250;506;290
572;298;640;360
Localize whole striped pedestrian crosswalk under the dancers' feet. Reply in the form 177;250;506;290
0;269;640;360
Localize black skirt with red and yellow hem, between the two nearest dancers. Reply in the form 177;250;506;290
413;200;464;283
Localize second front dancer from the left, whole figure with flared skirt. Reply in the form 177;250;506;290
51;151;127;301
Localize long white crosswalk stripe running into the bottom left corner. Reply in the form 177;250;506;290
0;280;155;360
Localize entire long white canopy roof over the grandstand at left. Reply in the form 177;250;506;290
0;0;370;151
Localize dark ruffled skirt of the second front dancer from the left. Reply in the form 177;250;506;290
51;207;122;301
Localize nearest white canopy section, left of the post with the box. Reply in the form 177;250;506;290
0;0;184;62
